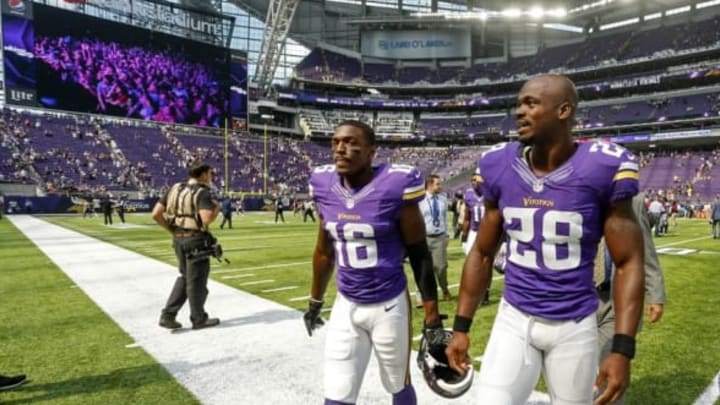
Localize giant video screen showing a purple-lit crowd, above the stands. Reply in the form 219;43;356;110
2;0;230;127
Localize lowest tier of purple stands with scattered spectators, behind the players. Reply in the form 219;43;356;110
0;110;720;215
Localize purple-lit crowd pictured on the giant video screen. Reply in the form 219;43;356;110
35;36;227;127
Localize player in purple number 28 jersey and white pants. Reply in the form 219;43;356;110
446;75;644;405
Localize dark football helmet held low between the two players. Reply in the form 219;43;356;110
417;329;474;398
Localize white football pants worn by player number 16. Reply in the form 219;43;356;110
325;291;412;404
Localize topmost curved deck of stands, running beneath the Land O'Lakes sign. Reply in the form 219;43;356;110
295;16;720;85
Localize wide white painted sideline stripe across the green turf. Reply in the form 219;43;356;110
8;215;548;405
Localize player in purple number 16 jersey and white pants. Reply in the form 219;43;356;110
304;121;444;405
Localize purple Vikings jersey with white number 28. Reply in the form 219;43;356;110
478;142;638;320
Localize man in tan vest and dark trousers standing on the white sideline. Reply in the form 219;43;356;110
152;162;220;329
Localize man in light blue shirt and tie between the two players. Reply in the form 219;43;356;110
420;174;452;301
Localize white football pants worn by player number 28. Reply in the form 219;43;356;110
478;299;598;405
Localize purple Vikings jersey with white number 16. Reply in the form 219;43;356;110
310;164;425;303
